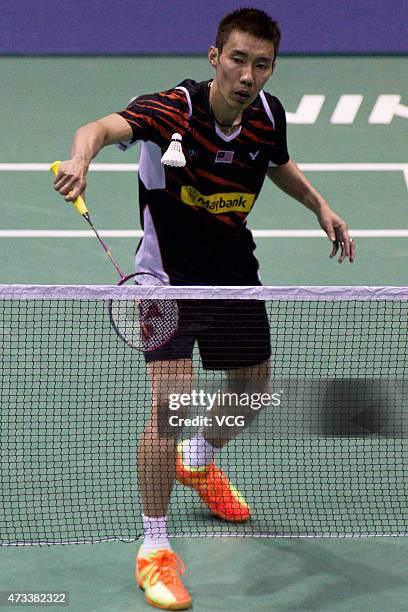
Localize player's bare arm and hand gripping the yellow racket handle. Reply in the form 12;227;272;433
54;113;133;202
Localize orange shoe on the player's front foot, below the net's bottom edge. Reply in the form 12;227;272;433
136;548;191;610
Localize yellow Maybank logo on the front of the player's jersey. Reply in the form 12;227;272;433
181;185;255;215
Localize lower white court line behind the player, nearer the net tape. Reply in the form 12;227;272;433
0;229;408;238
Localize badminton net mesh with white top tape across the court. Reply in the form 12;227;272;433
0;286;408;545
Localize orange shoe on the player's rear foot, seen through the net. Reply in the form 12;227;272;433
176;443;251;523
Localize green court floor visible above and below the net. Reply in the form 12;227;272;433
0;57;408;612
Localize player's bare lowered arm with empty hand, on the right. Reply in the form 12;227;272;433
268;159;356;263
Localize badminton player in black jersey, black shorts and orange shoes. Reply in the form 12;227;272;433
55;9;355;610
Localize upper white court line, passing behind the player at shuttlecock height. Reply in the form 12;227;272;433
0;163;408;172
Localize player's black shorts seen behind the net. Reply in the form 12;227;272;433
144;300;271;370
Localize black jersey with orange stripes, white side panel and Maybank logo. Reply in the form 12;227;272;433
119;80;289;285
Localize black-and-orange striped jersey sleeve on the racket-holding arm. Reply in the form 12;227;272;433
117;89;189;151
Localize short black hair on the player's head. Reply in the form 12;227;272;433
215;8;281;57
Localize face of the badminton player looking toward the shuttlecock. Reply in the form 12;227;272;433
208;30;275;110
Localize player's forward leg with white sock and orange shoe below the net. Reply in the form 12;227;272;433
136;359;193;610
